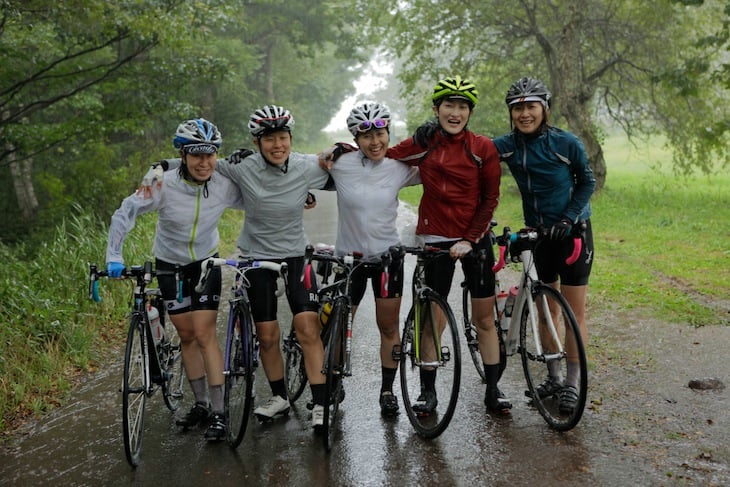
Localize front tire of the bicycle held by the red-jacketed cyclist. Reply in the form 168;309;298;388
399;290;461;438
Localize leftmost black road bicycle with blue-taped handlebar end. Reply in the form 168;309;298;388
89;262;185;467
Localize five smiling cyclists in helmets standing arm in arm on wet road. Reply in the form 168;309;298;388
107;72;595;440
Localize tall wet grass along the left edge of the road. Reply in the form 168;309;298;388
0;207;242;431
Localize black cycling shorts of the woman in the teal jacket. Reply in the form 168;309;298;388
534;219;594;286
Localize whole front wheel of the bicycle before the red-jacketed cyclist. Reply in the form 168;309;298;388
399;291;461;438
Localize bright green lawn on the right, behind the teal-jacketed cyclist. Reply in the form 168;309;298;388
401;136;730;326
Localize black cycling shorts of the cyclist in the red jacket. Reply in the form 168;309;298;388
426;238;494;298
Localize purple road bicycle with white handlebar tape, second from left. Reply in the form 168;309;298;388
195;257;287;448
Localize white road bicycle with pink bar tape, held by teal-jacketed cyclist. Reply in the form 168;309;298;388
474;227;588;431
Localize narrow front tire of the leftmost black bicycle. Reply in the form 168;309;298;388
122;313;147;467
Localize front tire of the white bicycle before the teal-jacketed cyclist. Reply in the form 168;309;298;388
520;282;588;431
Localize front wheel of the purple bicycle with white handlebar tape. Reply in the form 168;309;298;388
225;303;256;448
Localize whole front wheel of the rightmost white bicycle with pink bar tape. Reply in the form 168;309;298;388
520;282;588;431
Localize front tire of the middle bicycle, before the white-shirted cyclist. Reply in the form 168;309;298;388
322;299;347;451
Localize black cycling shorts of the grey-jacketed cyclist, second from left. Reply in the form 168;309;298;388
246;256;319;323
